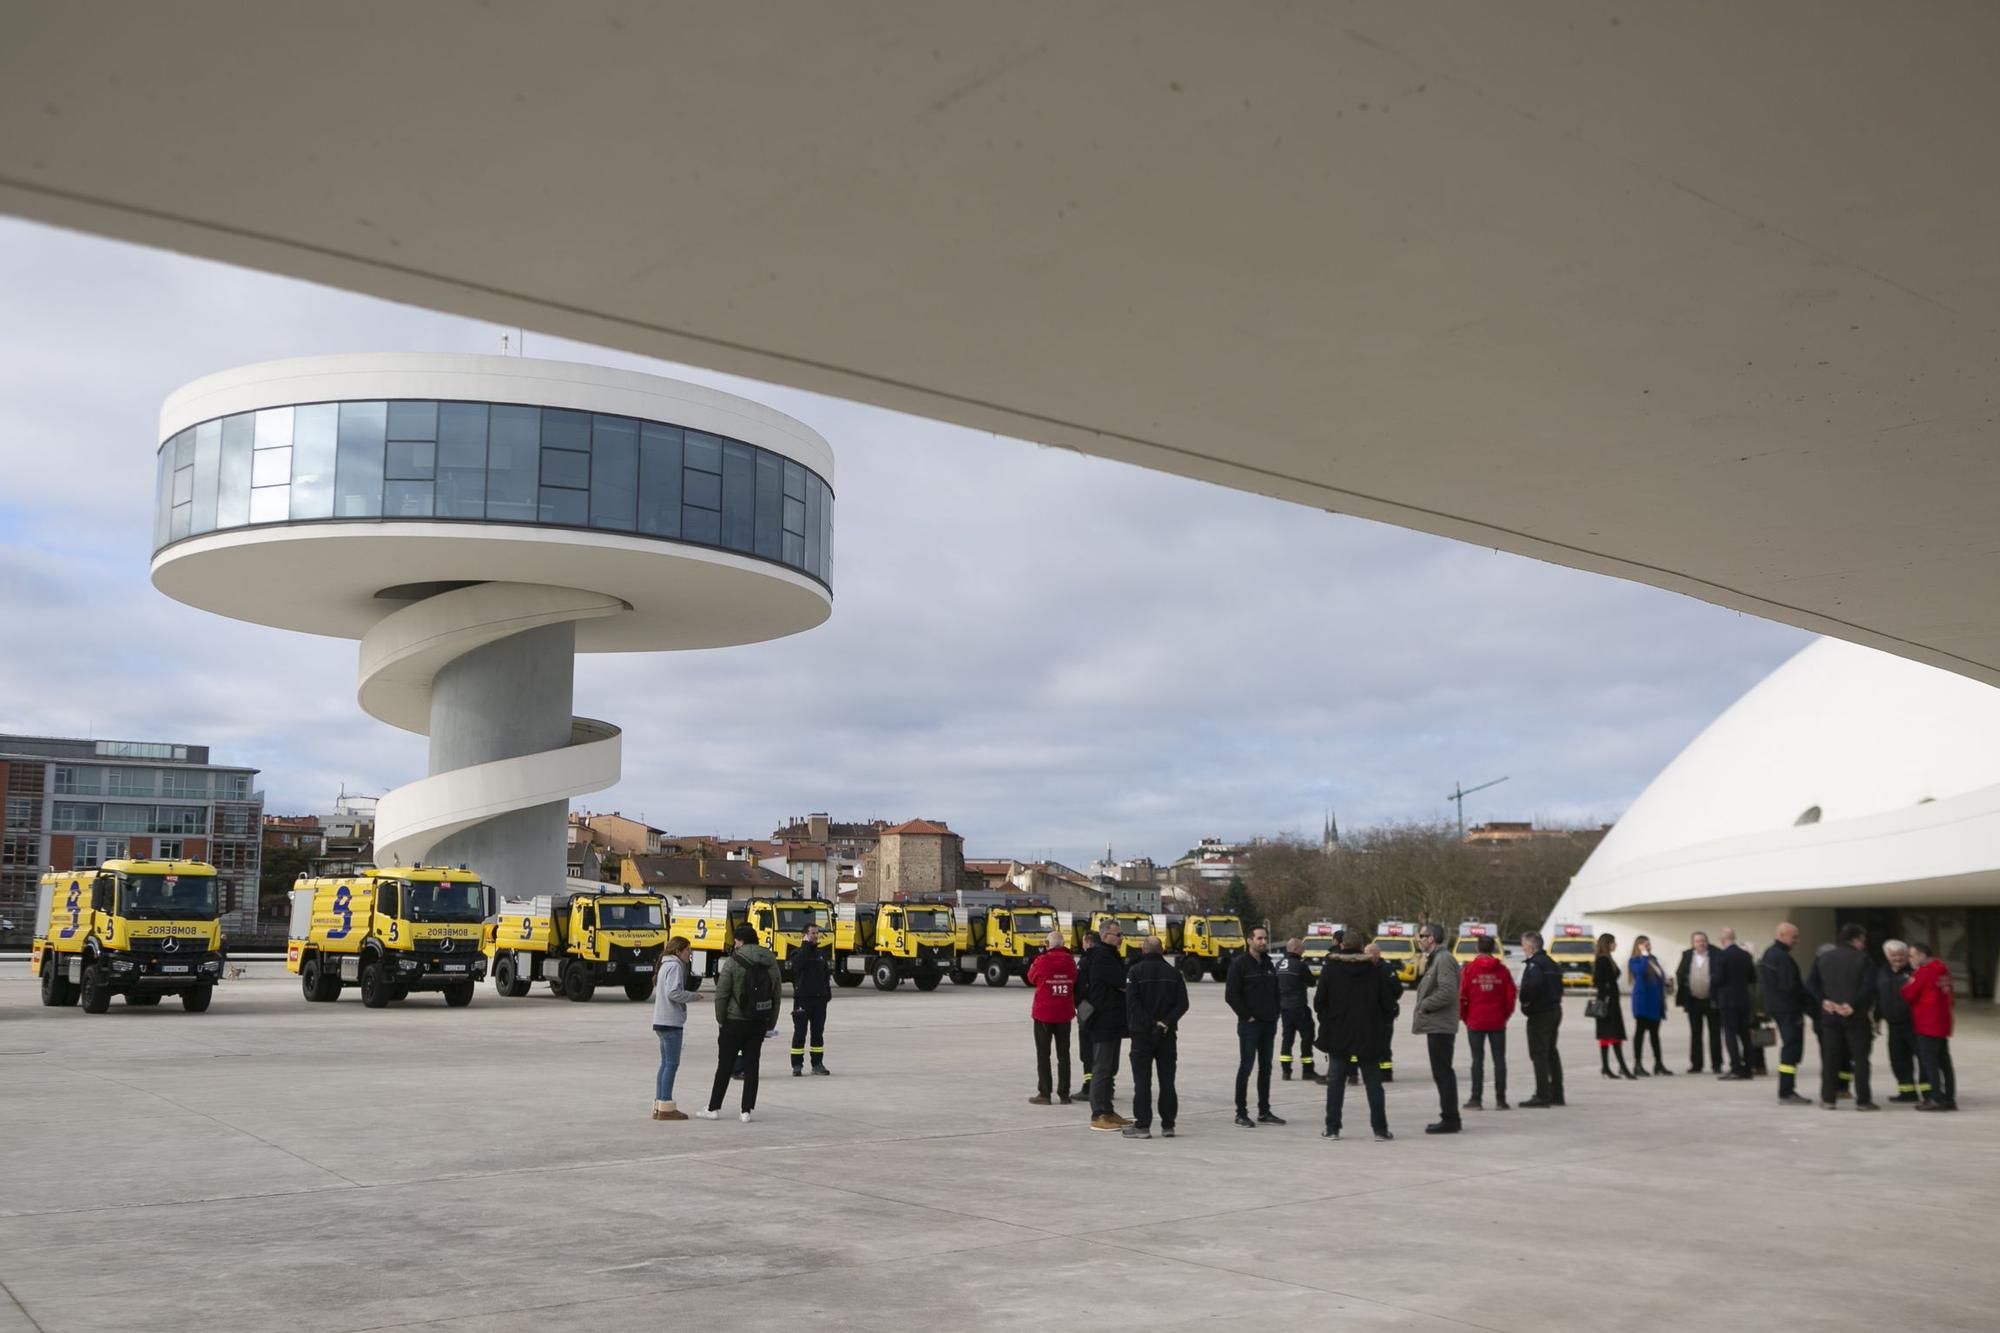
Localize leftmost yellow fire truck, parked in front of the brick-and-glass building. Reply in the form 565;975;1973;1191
28;859;224;1013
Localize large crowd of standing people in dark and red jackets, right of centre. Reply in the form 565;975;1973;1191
1028;923;1956;1141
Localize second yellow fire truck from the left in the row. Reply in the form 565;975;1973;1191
284;865;494;1009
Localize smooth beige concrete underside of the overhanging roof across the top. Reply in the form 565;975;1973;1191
0;0;2000;683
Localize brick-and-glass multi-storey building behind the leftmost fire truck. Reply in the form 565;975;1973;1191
0;737;264;937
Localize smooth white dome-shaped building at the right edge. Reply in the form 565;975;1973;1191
1550;638;2000;972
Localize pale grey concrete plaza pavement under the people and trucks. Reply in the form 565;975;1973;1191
0;963;2000;1333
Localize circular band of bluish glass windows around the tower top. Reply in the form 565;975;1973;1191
152;400;834;586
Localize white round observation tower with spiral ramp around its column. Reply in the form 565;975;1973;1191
152;354;834;897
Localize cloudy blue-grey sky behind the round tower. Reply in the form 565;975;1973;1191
0;220;1808;865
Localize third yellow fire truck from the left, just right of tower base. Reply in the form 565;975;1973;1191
484;889;668;1001
